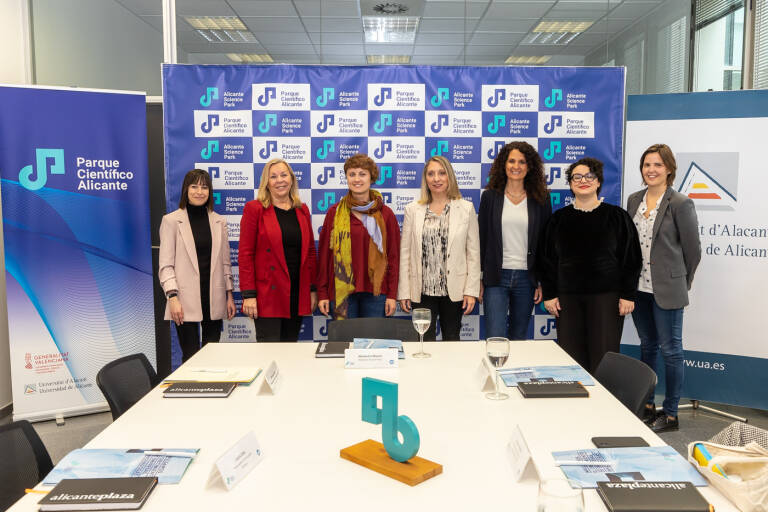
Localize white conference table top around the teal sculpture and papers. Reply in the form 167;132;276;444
10;341;737;512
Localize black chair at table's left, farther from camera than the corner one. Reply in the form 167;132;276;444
96;354;160;420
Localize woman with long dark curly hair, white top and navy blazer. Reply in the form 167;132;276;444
479;141;552;340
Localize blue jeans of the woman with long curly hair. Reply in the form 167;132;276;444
483;269;535;340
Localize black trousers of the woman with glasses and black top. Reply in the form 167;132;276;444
557;292;624;373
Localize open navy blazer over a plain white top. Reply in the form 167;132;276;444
478;189;552;286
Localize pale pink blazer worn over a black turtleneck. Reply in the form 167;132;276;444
157;209;234;322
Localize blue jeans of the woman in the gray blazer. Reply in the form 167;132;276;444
632;292;683;417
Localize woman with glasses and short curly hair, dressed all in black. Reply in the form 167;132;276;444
537;158;642;372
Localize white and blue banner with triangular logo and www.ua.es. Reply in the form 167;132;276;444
622;91;768;409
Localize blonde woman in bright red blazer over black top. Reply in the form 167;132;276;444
238;158;317;341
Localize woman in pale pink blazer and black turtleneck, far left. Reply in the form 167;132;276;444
158;169;235;361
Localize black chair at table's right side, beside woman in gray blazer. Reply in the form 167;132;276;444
595;352;657;418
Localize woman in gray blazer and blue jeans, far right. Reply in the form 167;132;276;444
627;144;701;432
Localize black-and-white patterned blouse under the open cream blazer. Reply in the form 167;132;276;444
421;204;450;297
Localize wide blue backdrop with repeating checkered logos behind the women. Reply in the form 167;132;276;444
163;65;624;360
